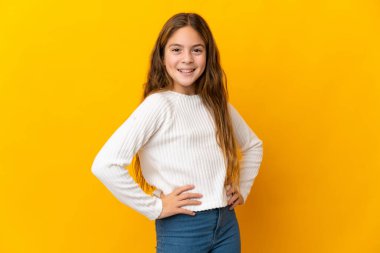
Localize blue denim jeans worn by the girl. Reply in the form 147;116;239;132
155;206;241;253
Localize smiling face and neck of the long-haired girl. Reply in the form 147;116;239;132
164;26;206;94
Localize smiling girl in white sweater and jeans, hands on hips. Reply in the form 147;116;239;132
91;13;263;253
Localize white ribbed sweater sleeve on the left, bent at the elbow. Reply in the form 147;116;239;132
91;94;168;220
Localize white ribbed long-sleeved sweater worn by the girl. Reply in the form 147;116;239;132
91;91;263;220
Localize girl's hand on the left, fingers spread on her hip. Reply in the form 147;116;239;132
158;185;203;219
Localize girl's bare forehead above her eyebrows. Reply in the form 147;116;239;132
166;26;204;47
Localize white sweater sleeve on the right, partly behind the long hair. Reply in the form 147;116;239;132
228;103;263;203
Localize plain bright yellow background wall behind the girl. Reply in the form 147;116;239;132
0;0;380;253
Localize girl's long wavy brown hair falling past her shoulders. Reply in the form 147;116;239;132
133;13;240;196
